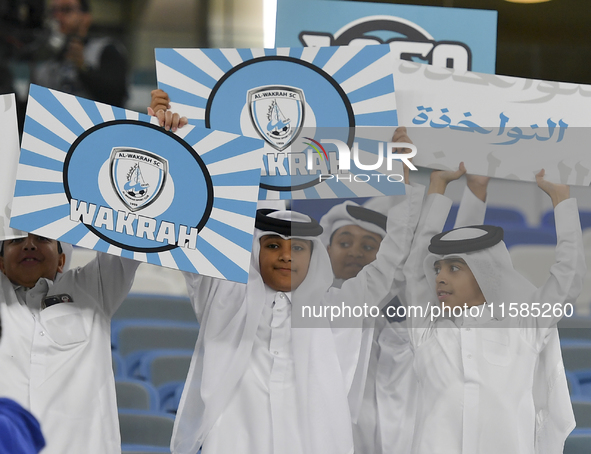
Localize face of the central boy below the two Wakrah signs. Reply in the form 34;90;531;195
259;235;312;292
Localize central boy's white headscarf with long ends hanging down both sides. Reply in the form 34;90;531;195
172;211;353;454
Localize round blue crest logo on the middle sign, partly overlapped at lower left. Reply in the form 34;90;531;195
205;56;355;191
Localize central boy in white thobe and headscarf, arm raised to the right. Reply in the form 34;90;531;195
171;186;422;454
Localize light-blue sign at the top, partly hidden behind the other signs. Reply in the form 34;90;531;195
275;0;497;74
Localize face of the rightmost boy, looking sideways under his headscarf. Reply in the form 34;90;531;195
433;258;485;307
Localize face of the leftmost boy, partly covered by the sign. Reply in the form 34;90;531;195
0;233;66;288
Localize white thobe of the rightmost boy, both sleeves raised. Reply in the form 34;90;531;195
407;195;585;454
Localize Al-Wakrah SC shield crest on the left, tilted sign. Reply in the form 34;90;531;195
111;147;168;211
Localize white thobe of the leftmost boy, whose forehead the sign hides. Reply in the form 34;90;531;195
0;254;139;454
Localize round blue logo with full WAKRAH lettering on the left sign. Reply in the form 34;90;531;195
63;120;213;253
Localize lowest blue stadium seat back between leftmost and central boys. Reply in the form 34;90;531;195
119;410;174;450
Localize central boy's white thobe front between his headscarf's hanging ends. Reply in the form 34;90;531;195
202;288;305;454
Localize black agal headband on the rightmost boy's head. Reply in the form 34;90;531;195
429;225;503;255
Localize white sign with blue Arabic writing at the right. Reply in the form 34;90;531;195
394;61;591;186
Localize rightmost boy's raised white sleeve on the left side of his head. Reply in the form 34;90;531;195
404;194;451;346
